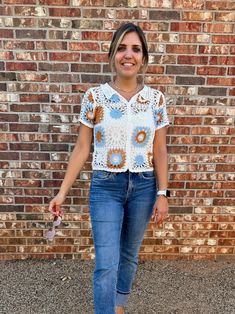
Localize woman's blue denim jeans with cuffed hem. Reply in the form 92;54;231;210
90;170;157;314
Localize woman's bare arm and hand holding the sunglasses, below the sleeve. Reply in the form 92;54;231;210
49;123;93;210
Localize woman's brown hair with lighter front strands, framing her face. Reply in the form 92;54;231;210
108;23;149;72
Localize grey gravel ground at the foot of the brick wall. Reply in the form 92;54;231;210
0;260;235;314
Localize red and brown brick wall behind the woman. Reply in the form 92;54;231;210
0;0;235;260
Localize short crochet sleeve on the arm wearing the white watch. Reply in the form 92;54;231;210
153;91;169;130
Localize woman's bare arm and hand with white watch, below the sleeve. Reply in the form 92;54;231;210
152;127;169;223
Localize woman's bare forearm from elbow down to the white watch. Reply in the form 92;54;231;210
153;147;168;190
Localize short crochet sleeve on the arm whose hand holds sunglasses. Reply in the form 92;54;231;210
79;88;95;128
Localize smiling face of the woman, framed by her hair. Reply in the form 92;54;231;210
114;32;143;78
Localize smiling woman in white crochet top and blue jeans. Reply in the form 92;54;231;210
49;23;169;314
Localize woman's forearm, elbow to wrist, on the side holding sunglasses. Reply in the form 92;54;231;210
59;147;89;197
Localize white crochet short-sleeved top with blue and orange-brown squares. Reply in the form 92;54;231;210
79;83;169;172
